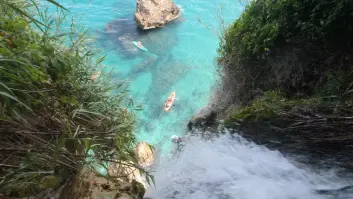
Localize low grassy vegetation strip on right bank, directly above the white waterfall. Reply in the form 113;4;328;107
225;91;353;151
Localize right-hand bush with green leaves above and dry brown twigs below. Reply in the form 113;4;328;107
218;0;353;107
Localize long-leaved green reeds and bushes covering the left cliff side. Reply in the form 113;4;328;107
0;0;146;197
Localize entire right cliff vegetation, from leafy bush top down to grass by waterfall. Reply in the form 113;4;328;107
218;0;353;145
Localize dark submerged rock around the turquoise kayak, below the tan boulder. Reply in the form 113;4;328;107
97;15;178;60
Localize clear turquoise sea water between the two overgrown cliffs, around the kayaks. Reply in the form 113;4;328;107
46;0;244;154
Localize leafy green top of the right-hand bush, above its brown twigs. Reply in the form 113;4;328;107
219;0;353;60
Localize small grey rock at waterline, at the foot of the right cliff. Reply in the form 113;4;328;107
188;106;217;131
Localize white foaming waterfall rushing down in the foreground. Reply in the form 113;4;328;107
146;130;353;199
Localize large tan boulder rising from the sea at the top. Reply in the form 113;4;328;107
135;0;180;30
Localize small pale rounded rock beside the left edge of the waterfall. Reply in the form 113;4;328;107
134;142;155;167
